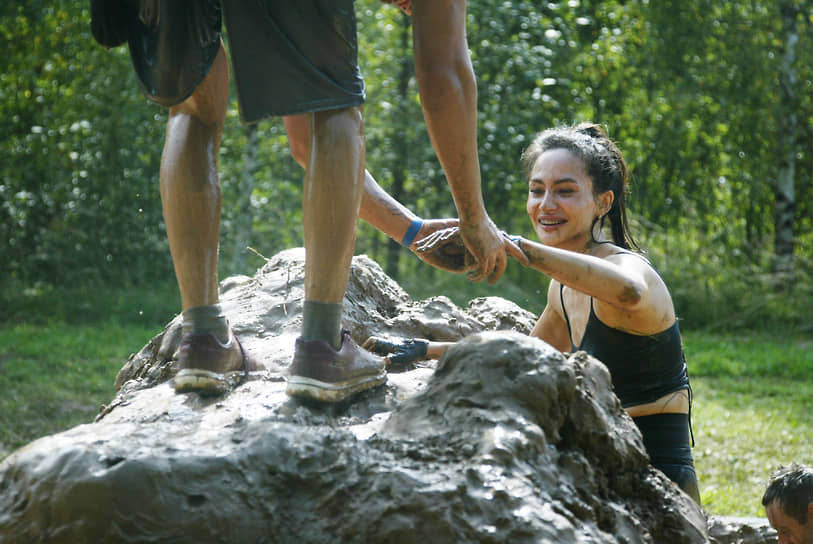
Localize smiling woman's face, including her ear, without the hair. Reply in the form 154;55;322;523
526;149;613;251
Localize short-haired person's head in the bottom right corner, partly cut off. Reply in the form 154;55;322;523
762;464;813;544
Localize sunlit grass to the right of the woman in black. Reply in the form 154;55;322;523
684;331;813;516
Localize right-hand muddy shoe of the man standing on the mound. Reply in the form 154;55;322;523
285;330;387;402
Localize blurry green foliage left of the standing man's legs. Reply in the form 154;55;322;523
0;2;171;283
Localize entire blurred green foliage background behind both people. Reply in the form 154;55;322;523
0;0;813;327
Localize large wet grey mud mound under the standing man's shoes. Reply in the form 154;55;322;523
0;250;708;544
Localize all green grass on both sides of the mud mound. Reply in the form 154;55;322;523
0;285;813;516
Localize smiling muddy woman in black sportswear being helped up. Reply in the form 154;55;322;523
367;124;700;503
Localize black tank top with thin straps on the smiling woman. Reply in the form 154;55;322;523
559;278;689;408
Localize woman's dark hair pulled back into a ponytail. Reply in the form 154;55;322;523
522;123;639;249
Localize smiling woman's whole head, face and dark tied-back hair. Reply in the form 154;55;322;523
522;123;637;249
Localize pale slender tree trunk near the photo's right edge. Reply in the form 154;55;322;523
774;0;799;275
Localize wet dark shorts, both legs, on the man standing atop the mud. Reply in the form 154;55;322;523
124;0;365;123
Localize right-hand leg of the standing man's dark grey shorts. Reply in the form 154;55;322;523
223;0;364;122
